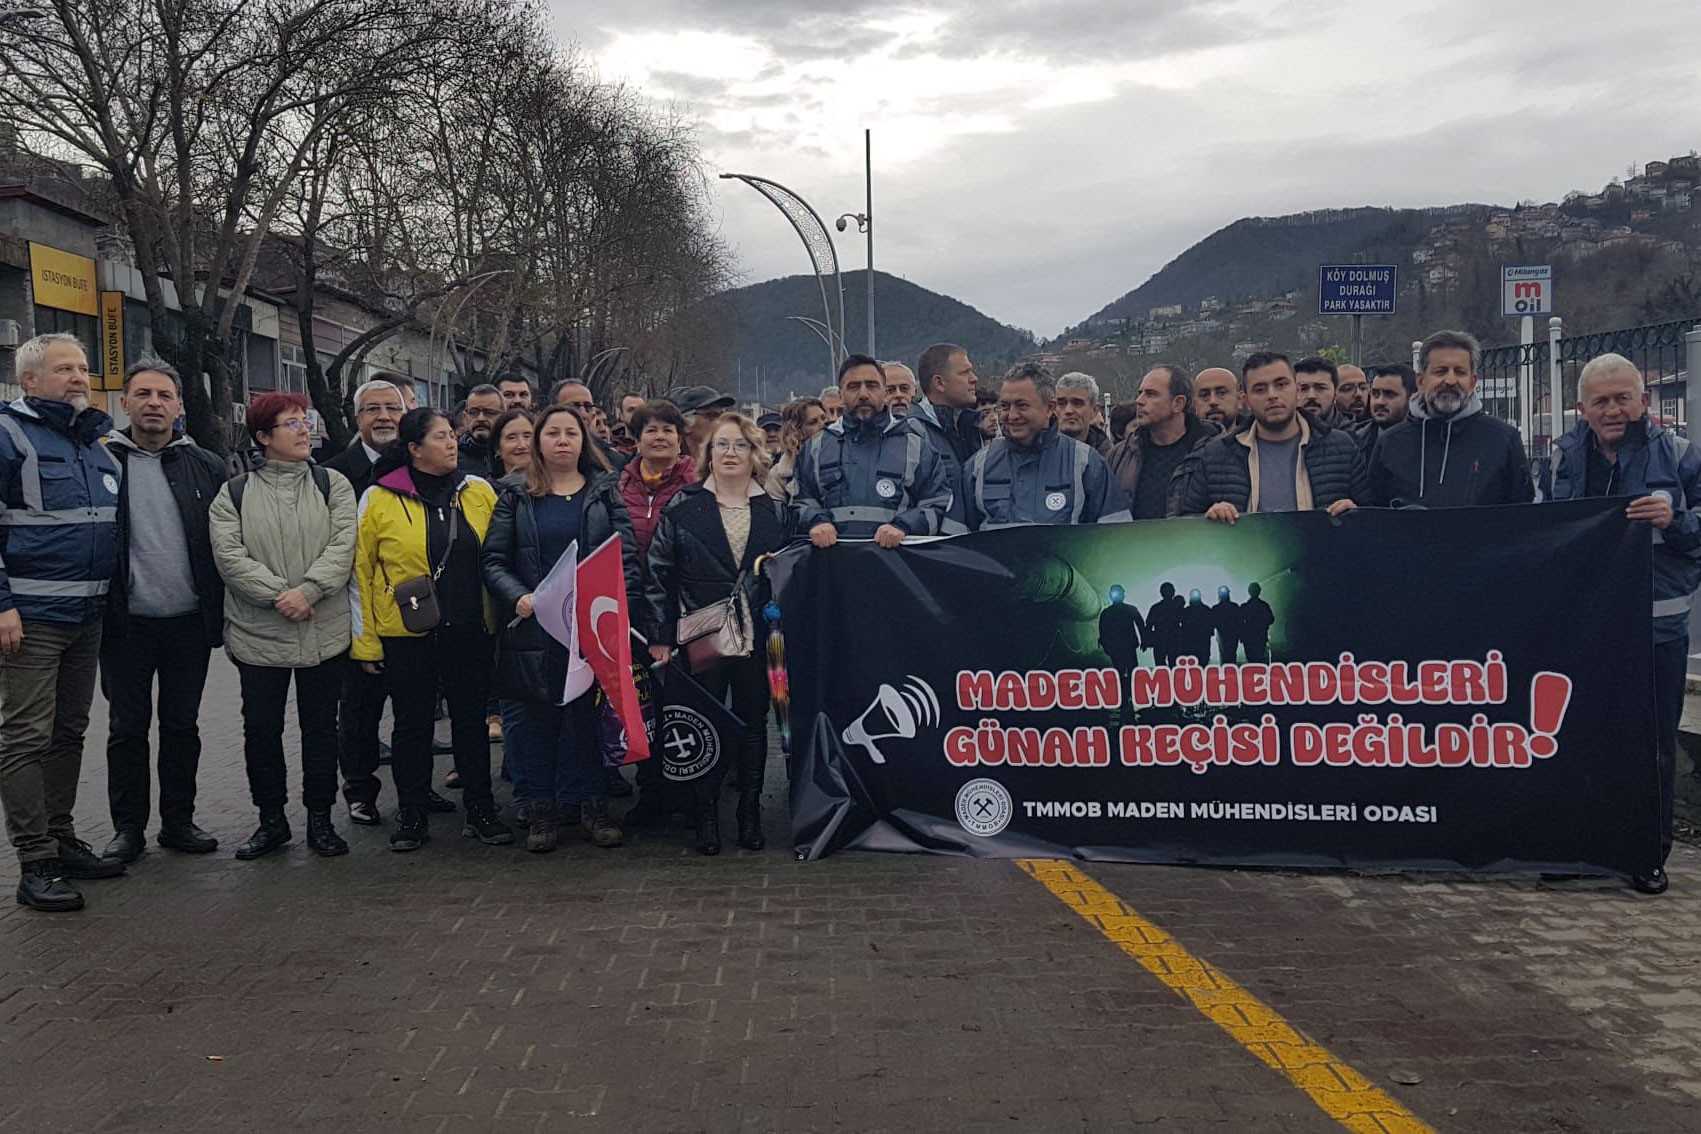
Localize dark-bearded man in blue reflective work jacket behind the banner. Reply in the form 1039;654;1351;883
796;354;951;547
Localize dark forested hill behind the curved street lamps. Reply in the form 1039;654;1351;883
690;272;1036;405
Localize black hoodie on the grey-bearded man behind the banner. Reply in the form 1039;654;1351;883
1371;393;1536;508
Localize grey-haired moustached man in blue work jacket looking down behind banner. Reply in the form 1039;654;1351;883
963;362;1129;530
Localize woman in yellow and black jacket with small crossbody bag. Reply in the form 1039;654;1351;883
352;408;514;850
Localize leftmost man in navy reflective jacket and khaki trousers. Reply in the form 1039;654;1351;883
0;335;124;910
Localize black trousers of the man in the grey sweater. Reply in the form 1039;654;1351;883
100;610;213;831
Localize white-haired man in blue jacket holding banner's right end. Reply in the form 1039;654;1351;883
1553;354;1701;894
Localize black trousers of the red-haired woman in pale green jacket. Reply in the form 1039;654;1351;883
236;655;347;811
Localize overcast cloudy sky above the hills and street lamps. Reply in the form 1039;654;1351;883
549;0;1701;335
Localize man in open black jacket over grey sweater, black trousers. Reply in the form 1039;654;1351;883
100;359;225;862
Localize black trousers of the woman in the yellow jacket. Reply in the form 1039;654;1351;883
383;626;495;809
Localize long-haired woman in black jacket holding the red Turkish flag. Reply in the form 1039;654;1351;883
483;406;643;852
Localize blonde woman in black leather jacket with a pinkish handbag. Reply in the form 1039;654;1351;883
645;413;793;855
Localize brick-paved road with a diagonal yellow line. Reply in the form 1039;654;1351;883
0;652;1701;1134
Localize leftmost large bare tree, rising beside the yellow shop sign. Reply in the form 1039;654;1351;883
0;0;458;452
